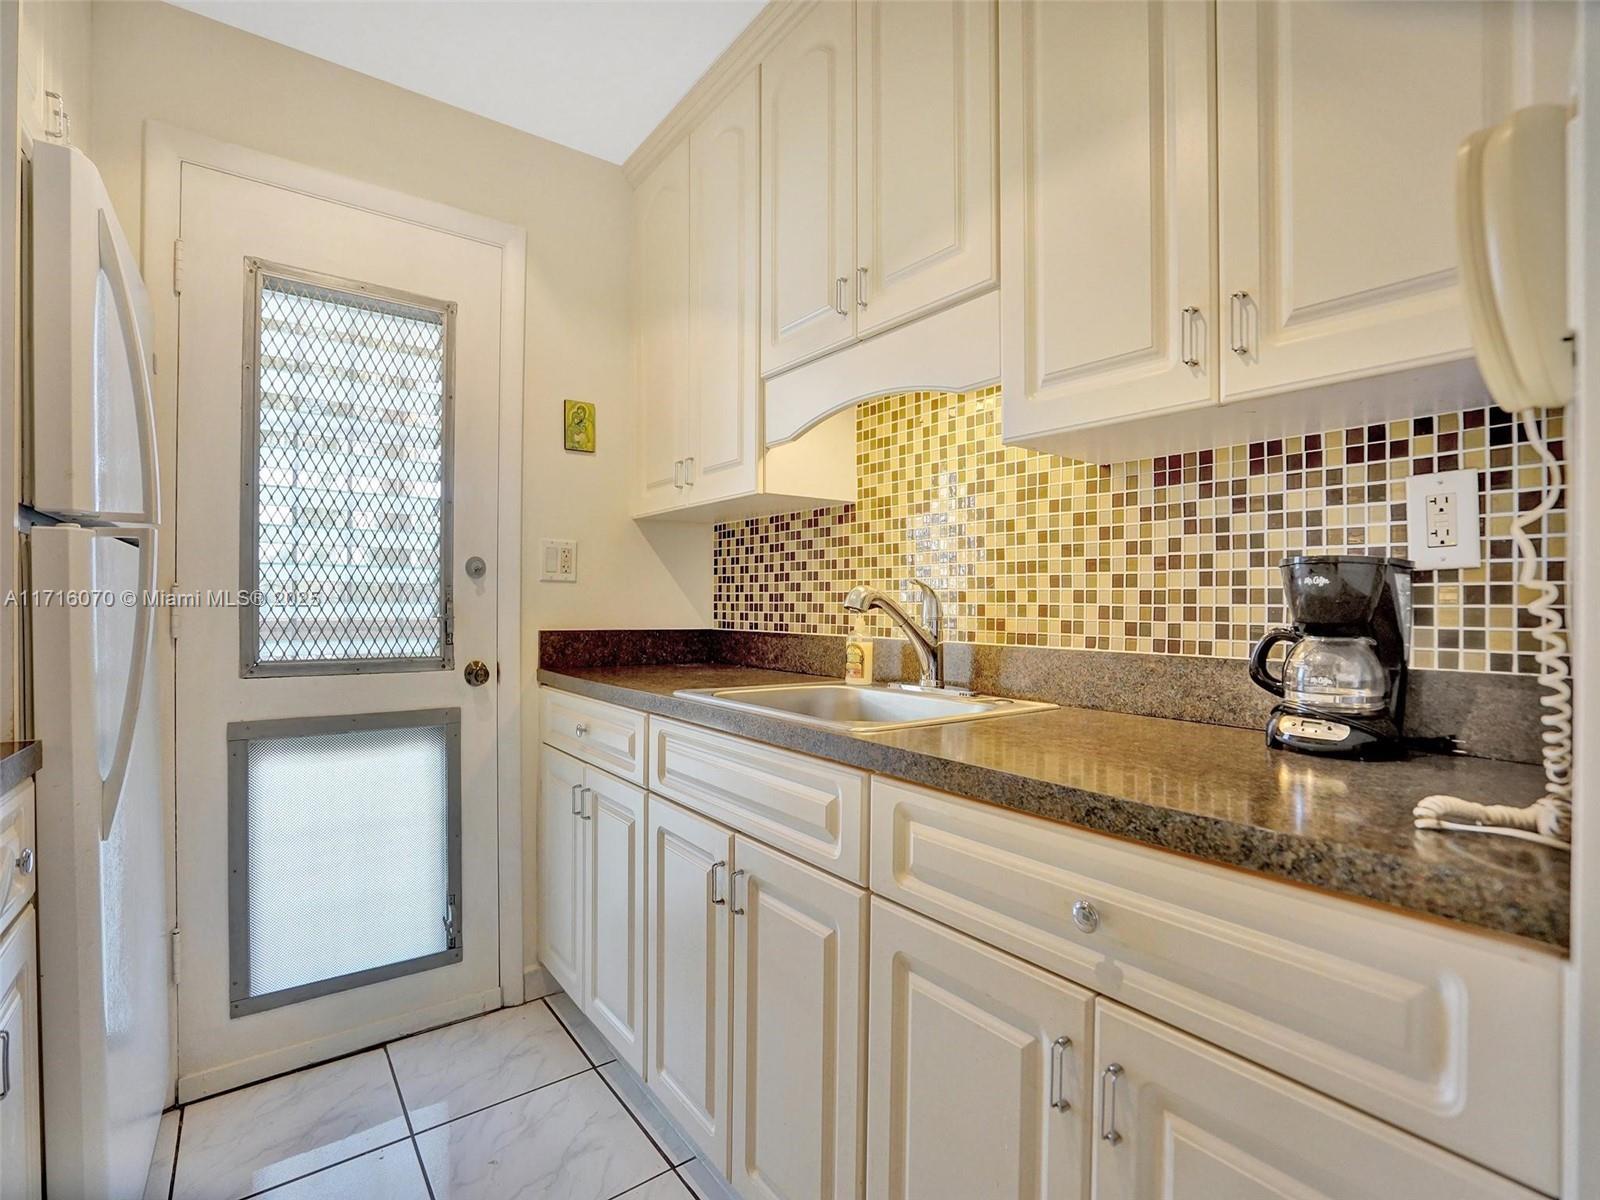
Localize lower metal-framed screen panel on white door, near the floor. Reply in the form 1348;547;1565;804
227;709;461;1016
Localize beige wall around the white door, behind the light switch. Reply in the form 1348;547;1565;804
88;0;710;963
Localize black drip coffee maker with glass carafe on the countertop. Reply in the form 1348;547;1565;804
1250;554;1411;758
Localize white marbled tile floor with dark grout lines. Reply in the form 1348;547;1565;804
144;992;728;1200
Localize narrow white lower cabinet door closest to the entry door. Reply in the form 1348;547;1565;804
539;746;584;1002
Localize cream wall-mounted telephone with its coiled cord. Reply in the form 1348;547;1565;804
1413;104;1574;848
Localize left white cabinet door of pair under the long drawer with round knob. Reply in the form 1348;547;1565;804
867;898;1094;1200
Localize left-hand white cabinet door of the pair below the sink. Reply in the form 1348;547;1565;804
645;797;733;1174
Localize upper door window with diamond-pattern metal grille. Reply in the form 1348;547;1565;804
240;259;454;677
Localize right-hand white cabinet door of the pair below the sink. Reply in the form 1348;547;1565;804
731;837;867;1200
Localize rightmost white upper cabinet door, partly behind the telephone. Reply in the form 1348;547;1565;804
1218;3;1515;400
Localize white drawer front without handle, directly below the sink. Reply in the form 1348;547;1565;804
650;717;867;883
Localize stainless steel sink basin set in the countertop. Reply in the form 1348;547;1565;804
677;683;1056;733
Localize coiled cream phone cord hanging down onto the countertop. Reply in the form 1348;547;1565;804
1411;408;1573;850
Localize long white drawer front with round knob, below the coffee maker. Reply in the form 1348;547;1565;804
872;779;1562;1194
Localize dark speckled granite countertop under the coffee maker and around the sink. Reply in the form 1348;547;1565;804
539;666;1571;949
